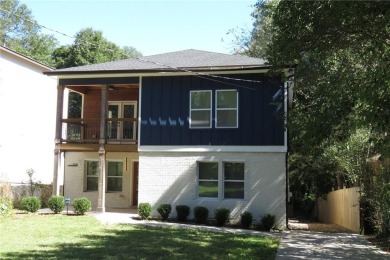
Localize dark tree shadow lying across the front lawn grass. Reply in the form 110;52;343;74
3;225;278;259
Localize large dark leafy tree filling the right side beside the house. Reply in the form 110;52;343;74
241;0;390;231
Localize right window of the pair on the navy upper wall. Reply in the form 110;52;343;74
215;89;238;128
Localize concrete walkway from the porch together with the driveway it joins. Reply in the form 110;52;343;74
88;210;390;260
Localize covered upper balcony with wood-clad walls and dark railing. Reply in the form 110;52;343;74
56;84;139;151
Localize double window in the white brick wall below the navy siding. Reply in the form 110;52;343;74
197;161;245;199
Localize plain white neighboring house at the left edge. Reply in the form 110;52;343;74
0;46;57;183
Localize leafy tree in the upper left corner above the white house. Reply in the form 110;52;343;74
0;0;58;65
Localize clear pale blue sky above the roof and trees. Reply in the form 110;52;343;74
19;0;256;56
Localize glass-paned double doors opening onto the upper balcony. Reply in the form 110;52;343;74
107;101;137;140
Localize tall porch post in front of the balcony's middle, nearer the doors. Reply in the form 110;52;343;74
96;86;108;212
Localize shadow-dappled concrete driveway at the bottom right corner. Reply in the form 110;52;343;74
276;231;390;260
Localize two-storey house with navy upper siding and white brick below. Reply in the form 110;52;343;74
45;50;287;225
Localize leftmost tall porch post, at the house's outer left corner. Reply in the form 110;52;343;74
53;85;65;195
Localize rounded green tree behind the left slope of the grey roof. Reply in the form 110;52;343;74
53;28;141;68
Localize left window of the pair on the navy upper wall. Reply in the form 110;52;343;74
190;90;212;128
